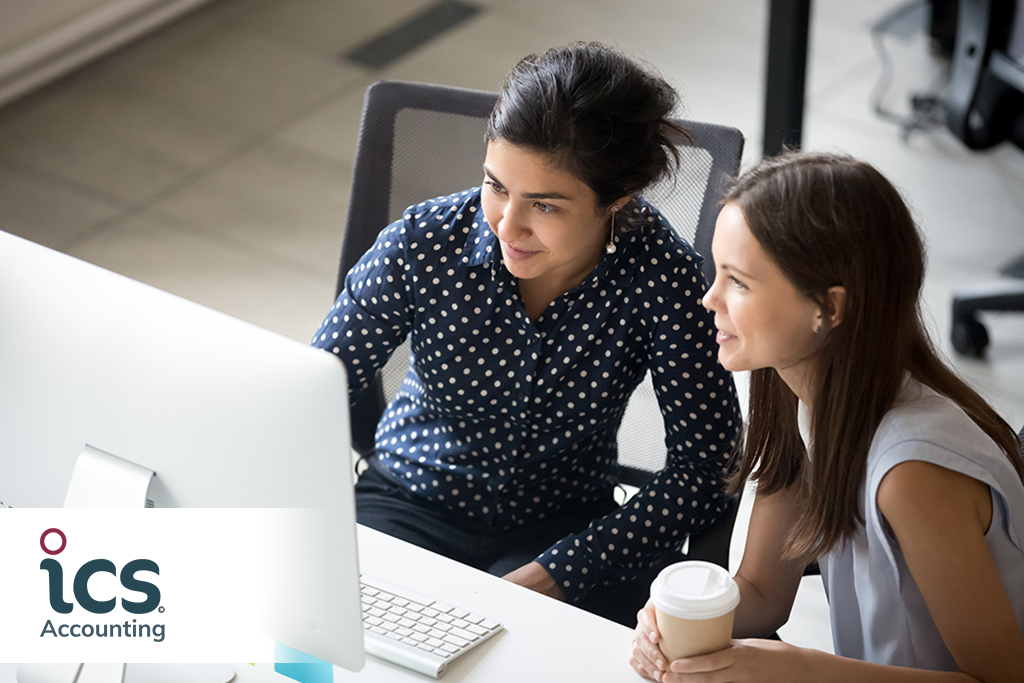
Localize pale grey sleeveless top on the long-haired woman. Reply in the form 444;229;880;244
800;379;1024;671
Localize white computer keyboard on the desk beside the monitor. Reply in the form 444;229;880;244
362;577;504;678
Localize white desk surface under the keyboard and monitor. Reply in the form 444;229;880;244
0;526;641;683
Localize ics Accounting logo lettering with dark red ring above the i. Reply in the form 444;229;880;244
39;528;165;643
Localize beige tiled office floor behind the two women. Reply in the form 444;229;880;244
0;0;1024;647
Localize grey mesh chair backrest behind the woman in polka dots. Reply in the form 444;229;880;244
336;81;743;485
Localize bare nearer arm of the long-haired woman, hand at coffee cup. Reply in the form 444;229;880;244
630;461;1024;683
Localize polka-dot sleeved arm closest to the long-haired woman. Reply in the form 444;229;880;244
539;249;741;599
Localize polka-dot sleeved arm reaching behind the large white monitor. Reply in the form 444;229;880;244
310;220;414;404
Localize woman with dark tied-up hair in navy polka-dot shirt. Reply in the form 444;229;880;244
312;43;740;626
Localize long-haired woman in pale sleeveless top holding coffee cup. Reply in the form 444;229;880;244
631;154;1024;683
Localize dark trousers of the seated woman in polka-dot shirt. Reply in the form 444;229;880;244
355;461;682;628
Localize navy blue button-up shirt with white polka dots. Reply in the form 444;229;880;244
312;187;740;600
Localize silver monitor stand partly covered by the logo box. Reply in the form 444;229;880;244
15;445;234;683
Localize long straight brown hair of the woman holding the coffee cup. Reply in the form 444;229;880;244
723;153;1024;557
